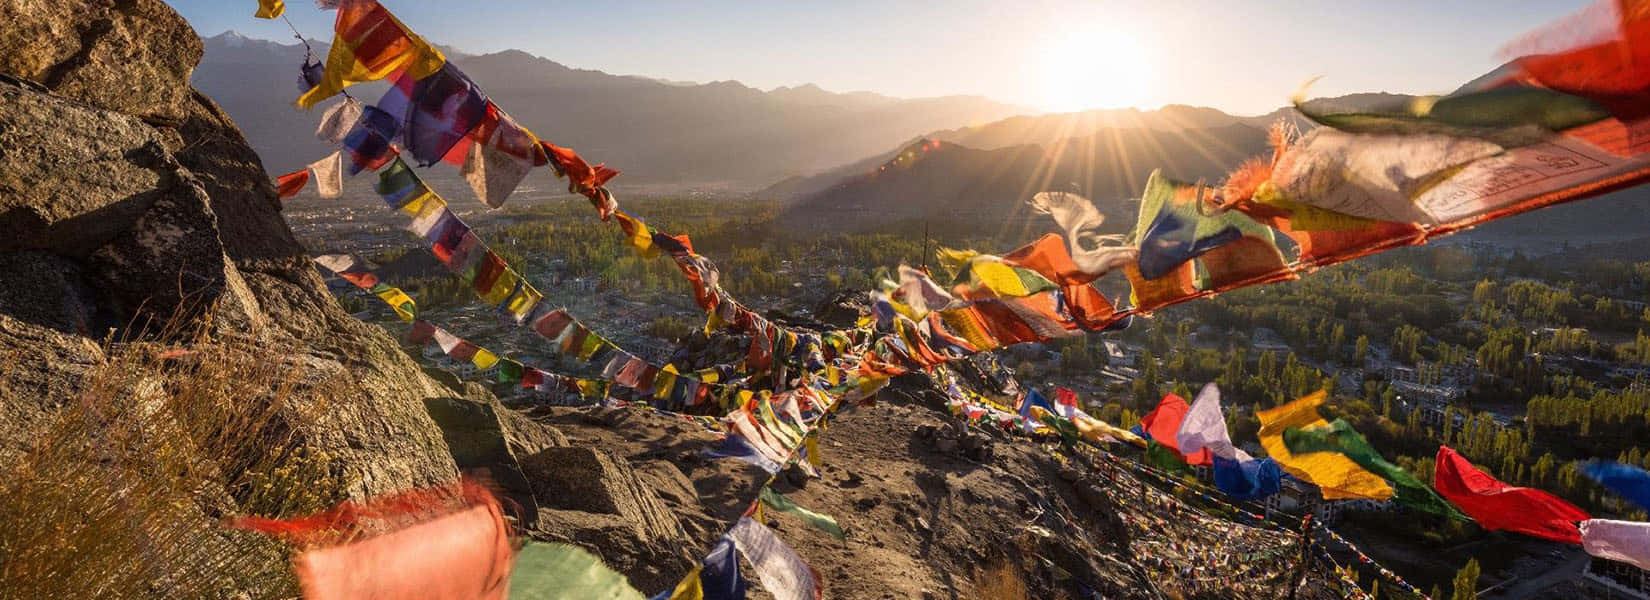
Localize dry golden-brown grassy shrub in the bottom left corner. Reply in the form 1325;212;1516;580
0;316;347;598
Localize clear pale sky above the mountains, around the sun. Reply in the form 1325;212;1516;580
168;0;1589;114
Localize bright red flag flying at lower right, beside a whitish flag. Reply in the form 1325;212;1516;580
1432;445;1592;544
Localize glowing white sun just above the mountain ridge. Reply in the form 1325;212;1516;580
1040;31;1152;112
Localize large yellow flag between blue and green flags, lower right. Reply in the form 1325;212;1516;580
1256;391;1393;499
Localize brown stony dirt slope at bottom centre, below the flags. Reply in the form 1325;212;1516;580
511;376;1341;600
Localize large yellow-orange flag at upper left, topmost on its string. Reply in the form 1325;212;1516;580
299;0;447;109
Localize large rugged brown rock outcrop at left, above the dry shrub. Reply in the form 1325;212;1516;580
0;0;481;496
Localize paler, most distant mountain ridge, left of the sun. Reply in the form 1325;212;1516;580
193;31;1028;190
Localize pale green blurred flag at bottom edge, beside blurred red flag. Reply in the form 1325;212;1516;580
510;542;647;600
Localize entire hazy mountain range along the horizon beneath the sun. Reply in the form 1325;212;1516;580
193;31;1650;248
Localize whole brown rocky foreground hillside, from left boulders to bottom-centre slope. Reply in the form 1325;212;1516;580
0;0;1328;598
